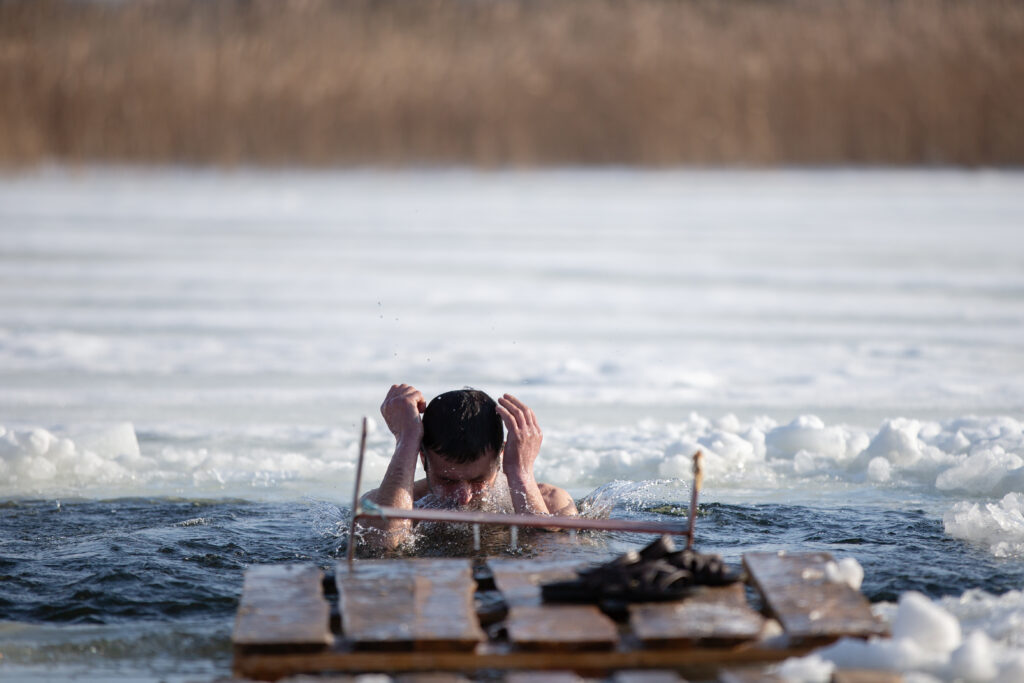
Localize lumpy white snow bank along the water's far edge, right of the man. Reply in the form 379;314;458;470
538;413;1024;555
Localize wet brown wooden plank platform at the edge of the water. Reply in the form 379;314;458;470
232;553;884;681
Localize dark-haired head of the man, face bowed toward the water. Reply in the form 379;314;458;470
421;389;504;506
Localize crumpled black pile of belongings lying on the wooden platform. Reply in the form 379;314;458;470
541;536;739;603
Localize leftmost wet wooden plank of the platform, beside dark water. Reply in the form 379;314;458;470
231;564;334;651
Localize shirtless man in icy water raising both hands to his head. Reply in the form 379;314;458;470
359;384;577;547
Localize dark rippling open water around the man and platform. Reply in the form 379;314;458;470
0;499;1024;674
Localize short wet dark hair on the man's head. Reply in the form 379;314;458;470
423;388;504;465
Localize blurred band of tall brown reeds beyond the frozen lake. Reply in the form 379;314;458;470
0;0;1024;166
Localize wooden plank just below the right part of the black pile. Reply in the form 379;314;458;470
630;584;765;647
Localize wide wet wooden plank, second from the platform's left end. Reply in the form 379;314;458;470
335;559;484;650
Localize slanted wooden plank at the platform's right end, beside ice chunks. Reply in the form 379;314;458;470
743;552;887;642
